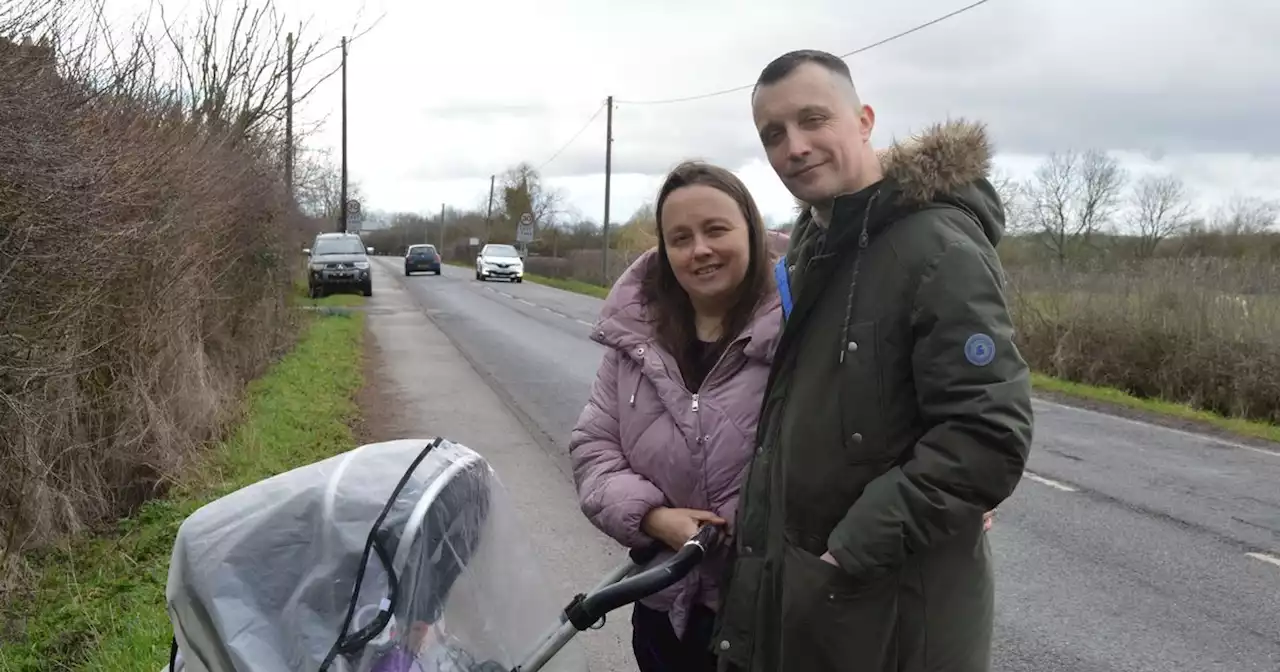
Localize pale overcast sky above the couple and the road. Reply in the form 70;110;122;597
267;0;1280;220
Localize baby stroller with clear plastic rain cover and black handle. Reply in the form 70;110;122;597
164;438;718;672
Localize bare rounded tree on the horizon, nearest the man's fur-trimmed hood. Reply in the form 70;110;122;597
1025;150;1126;262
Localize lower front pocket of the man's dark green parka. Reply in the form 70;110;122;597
781;545;899;672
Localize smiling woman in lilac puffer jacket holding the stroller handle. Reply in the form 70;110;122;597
570;163;782;672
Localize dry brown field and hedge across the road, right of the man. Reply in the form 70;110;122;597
1007;260;1280;424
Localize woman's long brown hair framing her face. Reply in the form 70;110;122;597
644;161;773;384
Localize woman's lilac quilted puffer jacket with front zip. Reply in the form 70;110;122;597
568;248;782;634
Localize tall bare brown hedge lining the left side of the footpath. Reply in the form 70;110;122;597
0;0;360;585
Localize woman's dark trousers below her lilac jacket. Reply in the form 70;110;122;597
631;604;716;672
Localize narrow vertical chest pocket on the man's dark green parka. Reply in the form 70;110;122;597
837;321;891;465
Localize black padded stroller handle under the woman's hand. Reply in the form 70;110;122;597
564;525;721;631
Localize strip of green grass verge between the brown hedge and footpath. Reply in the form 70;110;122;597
0;304;364;672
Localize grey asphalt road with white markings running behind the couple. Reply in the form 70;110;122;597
378;259;1280;672
